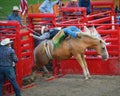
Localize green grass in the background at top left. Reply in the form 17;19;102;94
0;0;68;19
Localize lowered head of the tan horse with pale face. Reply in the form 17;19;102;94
94;39;109;60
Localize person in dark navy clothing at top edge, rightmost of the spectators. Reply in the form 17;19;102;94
78;0;91;15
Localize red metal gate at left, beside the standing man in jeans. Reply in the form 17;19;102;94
0;21;34;93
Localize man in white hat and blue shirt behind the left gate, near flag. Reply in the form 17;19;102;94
7;6;22;26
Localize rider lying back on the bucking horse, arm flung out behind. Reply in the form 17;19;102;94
30;26;81;47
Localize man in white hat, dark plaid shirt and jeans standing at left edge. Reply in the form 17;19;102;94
0;38;22;96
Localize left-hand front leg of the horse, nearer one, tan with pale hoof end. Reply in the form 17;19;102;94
74;54;89;79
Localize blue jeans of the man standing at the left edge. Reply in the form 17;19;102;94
0;67;22;96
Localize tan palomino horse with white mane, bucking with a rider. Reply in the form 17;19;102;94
34;28;109;79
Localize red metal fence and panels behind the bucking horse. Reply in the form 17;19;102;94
28;7;120;75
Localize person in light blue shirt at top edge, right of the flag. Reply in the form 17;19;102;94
39;0;59;14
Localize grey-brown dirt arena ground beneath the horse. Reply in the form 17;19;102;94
11;74;120;96
